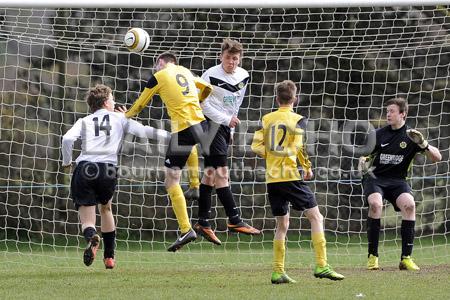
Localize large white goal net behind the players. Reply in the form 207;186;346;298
0;6;450;265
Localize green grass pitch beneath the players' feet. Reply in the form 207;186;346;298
0;241;450;299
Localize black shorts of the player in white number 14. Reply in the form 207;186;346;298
70;161;117;209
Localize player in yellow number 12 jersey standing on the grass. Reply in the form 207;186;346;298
252;80;344;284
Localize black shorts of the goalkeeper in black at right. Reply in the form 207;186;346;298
362;176;412;211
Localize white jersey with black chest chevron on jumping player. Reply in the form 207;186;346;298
202;64;250;126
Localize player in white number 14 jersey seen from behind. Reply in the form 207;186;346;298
62;84;166;269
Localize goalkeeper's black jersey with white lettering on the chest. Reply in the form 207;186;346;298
371;125;423;179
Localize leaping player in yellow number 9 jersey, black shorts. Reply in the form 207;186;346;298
126;52;212;252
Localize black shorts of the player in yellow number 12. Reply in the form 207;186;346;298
267;180;317;217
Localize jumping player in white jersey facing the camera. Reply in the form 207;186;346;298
186;39;261;245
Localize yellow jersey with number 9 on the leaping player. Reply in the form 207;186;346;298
125;63;212;133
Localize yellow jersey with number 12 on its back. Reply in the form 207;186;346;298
252;107;311;183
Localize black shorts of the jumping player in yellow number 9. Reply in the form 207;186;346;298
164;121;208;169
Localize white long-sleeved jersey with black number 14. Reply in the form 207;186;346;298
62;109;170;165
